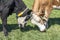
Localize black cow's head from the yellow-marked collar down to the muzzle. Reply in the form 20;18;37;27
18;8;31;28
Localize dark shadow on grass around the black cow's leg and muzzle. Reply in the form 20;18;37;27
0;24;38;32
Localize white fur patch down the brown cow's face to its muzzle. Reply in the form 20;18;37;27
31;14;46;31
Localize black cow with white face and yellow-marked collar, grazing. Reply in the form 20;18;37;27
0;0;29;36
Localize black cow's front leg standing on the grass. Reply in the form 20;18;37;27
1;7;9;36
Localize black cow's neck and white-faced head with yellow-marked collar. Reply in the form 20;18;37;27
15;0;30;28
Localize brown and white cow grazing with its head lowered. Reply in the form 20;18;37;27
31;0;60;31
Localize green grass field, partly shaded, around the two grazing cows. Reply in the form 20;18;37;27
0;0;60;40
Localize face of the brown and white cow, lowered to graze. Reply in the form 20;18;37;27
31;13;47;31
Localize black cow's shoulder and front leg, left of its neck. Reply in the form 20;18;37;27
0;0;15;35
